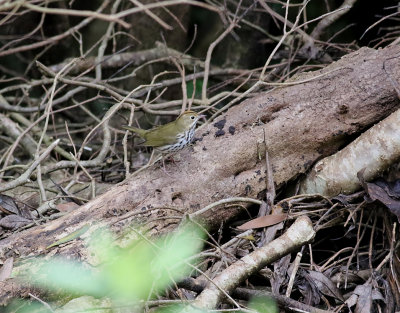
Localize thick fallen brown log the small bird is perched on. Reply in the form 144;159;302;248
0;47;400;294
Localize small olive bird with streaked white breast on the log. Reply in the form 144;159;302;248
123;111;204;153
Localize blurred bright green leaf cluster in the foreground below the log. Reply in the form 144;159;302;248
23;226;203;302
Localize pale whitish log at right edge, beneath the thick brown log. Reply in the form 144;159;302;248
300;110;400;196
